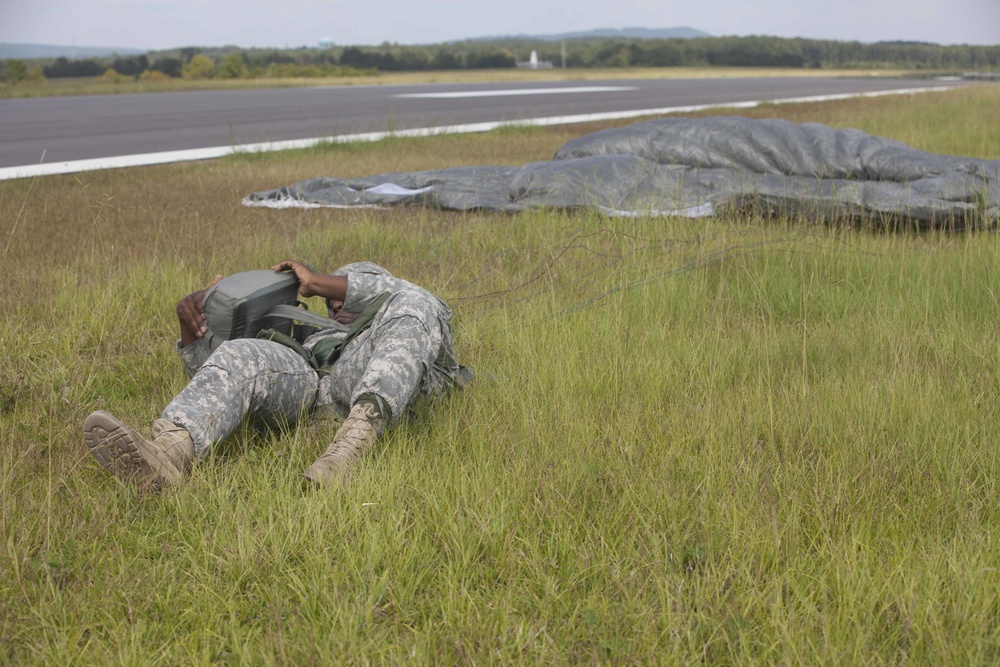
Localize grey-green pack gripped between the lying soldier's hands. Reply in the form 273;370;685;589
204;270;346;350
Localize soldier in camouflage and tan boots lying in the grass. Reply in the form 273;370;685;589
83;260;472;491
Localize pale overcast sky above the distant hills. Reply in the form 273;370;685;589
0;0;1000;50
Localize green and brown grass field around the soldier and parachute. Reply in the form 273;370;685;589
0;86;1000;665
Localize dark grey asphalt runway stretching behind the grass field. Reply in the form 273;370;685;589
0;77;964;167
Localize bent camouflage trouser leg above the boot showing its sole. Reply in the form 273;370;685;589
162;339;318;457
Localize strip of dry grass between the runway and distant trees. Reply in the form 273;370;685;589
0;67;904;99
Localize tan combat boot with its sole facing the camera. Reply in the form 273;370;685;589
83;410;194;493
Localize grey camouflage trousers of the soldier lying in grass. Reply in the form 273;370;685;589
162;308;441;458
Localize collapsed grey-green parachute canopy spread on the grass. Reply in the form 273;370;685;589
244;117;1000;227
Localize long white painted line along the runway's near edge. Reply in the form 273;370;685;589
0;86;953;181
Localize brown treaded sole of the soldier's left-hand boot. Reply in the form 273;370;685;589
83;410;162;493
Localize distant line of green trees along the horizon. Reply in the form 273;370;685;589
5;36;1000;85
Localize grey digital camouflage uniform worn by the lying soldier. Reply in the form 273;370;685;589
162;262;472;458
